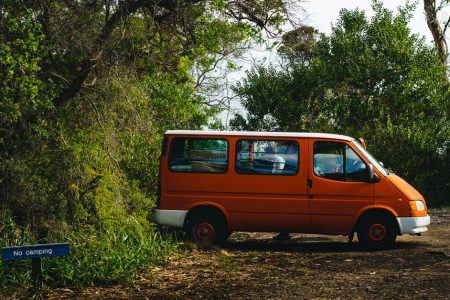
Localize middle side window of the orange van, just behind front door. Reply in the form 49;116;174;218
236;140;299;175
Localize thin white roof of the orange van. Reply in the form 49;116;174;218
165;130;354;141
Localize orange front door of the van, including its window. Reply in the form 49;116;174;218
307;139;374;234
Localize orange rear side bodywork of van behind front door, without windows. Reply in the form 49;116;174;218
159;136;309;232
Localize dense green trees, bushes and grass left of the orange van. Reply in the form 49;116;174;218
0;0;294;286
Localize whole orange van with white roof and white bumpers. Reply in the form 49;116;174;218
155;130;430;249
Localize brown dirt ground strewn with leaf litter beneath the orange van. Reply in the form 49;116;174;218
44;209;450;299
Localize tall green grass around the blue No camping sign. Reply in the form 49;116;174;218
0;218;177;297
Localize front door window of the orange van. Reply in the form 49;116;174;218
314;142;367;181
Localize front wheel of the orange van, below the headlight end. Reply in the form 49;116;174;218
357;213;398;250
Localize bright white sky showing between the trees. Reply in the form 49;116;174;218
219;0;450;125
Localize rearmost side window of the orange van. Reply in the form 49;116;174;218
169;138;228;173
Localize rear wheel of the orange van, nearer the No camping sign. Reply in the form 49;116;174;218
187;211;227;248
